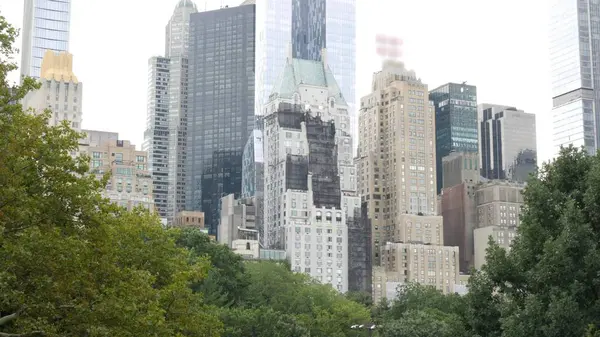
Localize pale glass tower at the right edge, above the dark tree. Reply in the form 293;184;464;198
550;0;600;154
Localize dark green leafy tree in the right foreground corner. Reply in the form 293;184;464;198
470;147;600;337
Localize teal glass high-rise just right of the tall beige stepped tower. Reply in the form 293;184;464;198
429;83;478;194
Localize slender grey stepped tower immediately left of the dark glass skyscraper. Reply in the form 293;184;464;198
143;0;197;222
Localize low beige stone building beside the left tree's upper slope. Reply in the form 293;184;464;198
81;140;154;211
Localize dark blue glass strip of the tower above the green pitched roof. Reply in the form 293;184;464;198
292;0;327;61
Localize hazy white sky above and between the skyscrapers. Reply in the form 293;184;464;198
0;0;552;160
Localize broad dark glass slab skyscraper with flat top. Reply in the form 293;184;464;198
185;2;256;235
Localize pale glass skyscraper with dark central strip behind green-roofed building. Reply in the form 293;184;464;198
255;0;358;138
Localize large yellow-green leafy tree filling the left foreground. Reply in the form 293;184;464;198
0;16;223;337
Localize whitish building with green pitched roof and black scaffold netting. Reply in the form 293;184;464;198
264;50;360;292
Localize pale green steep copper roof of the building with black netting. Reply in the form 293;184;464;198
272;59;347;104
